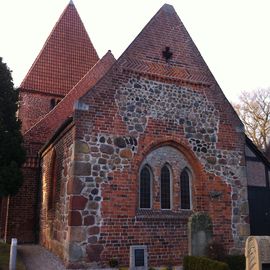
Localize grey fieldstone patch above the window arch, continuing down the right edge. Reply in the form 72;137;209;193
115;77;249;249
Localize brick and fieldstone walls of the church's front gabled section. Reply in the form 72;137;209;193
14;5;249;268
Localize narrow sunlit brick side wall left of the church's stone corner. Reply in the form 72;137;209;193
40;124;76;259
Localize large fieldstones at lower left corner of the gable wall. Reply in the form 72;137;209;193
69;134;137;266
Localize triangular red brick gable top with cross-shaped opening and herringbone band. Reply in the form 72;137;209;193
120;4;213;83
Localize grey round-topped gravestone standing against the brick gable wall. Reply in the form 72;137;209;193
188;213;213;256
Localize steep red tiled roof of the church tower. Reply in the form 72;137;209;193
20;1;99;95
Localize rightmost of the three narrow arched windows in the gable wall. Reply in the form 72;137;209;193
180;169;191;209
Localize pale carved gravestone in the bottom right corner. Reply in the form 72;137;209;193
245;236;270;270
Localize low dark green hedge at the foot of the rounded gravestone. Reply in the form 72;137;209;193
184;256;230;270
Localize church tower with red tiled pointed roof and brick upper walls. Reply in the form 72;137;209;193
19;1;99;133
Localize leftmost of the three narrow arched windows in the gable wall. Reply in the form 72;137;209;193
140;166;151;208
